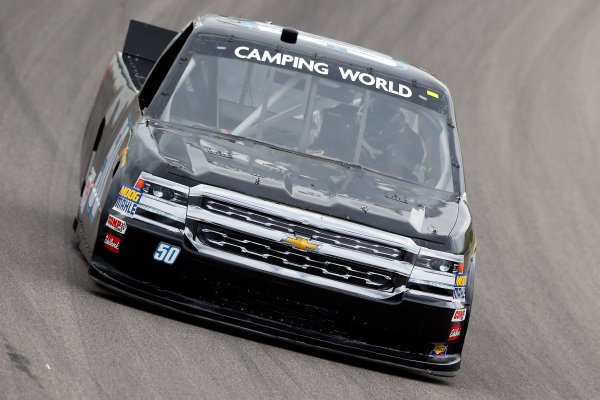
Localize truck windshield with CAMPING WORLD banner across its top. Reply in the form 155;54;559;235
149;36;454;192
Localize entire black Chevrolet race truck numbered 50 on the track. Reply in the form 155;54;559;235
74;15;476;376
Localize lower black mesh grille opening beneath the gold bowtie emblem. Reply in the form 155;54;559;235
196;224;402;291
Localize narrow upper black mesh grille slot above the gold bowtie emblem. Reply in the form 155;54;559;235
202;198;406;261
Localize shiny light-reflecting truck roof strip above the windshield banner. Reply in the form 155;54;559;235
194;14;450;98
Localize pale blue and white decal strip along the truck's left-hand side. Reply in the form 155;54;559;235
82;113;133;222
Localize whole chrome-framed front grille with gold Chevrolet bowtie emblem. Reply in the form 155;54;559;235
185;191;418;299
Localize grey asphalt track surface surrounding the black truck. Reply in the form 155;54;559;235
0;0;600;400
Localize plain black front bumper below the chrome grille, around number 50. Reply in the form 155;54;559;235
89;216;462;376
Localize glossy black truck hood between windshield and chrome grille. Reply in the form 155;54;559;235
149;125;459;245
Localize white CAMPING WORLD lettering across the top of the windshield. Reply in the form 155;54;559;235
234;46;412;98
